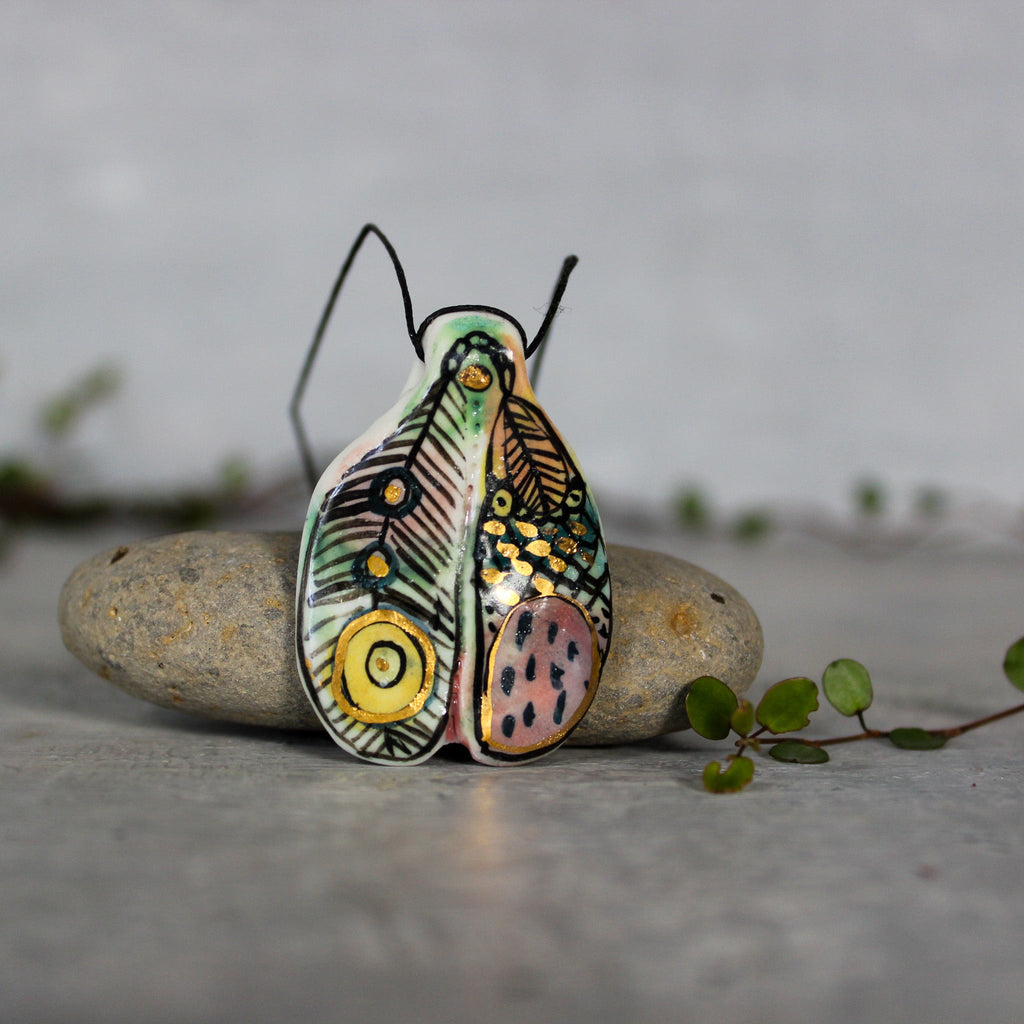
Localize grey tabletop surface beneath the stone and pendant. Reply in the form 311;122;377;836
0;532;1024;1024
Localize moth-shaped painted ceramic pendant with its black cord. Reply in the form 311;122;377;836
292;224;611;765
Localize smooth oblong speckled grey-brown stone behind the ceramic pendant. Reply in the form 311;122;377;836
60;531;763;745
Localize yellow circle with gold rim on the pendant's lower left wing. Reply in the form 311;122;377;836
331;609;434;722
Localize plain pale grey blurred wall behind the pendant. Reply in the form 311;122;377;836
0;0;1024;520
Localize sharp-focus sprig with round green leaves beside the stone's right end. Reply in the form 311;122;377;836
686;637;1024;793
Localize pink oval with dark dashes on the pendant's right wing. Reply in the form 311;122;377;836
481;595;598;754
